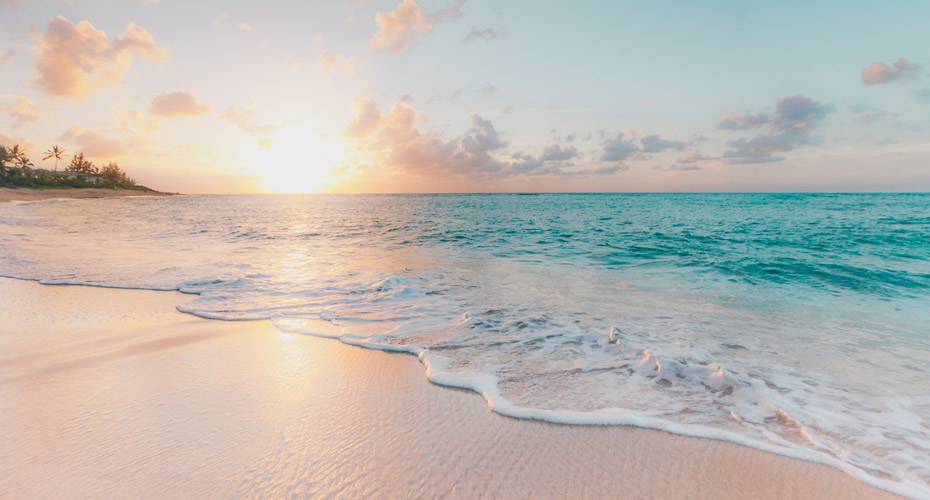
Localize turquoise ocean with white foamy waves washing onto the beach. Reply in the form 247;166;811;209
0;194;930;498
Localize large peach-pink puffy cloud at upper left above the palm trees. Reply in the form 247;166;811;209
31;16;167;101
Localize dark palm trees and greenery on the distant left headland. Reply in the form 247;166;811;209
0;145;152;191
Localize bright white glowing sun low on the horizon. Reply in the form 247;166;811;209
252;121;346;194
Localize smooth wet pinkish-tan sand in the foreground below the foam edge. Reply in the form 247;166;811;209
0;278;896;499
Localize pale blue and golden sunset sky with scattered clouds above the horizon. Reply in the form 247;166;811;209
0;0;930;193
